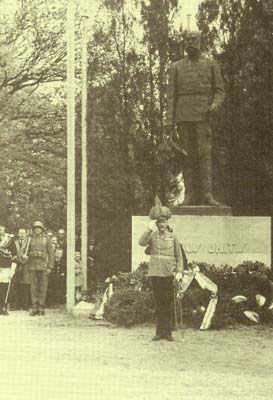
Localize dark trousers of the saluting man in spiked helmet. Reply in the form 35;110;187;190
151;276;173;337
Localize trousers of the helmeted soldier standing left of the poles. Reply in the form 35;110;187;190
29;270;48;308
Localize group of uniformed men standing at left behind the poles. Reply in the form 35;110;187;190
0;221;66;316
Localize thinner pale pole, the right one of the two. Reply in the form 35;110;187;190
81;15;88;290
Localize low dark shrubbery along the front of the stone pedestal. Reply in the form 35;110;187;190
102;261;273;329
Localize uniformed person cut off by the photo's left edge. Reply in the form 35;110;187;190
0;225;16;315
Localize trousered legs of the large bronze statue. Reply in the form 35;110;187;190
177;121;212;200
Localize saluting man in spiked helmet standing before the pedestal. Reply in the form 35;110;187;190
139;199;183;341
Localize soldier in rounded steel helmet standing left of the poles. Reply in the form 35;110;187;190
28;221;54;316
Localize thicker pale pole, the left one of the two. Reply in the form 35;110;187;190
66;0;75;312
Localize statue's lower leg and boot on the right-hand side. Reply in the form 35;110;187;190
200;158;221;207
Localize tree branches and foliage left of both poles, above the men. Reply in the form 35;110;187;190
0;0;66;229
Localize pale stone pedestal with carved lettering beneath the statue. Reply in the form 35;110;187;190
132;214;271;269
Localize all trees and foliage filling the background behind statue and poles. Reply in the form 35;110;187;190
0;0;273;278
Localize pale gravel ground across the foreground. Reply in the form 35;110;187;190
0;310;273;400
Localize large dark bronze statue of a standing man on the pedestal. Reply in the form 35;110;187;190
166;31;224;206
